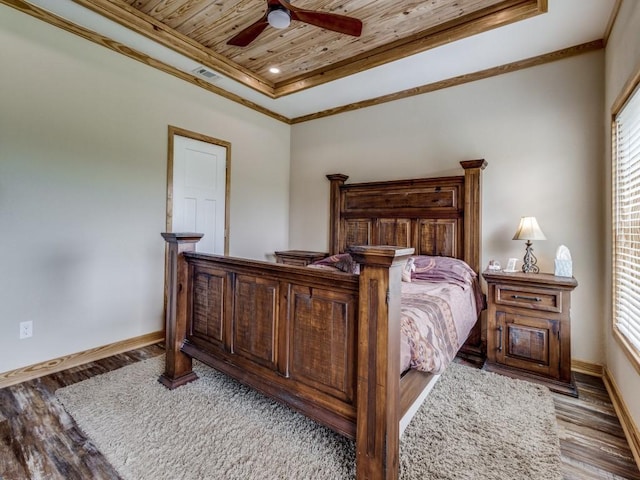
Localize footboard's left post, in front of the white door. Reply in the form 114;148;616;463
158;233;202;390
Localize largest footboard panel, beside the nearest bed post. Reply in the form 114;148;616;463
289;286;358;403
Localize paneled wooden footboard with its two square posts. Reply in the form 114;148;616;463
159;234;413;479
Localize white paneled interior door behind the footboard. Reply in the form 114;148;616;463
171;135;227;255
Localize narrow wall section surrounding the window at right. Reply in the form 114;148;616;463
602;0;640;434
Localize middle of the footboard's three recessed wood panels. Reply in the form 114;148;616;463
231;275;279;369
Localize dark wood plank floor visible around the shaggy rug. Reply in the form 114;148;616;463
0;345;640;480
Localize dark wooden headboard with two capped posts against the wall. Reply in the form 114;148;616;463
327;159;487;272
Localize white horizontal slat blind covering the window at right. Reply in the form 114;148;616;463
613;81;640;355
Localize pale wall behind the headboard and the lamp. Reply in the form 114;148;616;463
289;51;605;363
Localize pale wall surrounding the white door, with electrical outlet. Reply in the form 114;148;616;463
0;1;290;372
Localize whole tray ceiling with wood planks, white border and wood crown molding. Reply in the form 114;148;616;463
0;0;621;123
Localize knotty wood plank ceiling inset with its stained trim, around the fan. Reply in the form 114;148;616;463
74;0;547;98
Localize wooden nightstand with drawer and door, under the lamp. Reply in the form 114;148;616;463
482;271;578;396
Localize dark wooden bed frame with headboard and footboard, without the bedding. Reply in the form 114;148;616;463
159;160;487;479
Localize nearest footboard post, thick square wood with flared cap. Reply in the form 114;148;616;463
350;246;414;480
